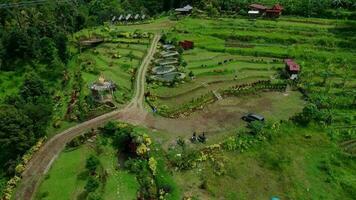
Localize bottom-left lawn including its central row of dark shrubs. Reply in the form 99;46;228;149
36;134;138;200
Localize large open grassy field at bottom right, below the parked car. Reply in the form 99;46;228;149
175;128;356;200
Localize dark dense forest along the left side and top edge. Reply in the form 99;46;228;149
0;0;356;194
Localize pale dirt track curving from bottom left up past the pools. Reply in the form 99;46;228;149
15;35;160;200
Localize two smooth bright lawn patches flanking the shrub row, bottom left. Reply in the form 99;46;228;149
37;141;138;200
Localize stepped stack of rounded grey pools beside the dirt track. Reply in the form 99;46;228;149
150;44;185;83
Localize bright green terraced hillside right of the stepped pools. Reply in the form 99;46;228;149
149;17;356;122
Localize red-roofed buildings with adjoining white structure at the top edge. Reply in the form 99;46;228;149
248;4;284;18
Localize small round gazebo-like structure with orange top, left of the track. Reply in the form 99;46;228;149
90;75;116;102
